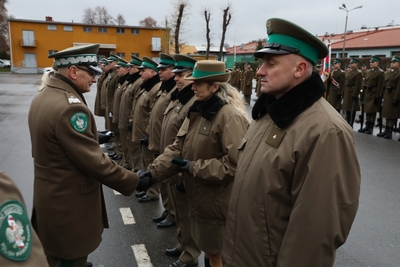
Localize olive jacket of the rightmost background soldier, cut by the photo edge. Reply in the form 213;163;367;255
382;68;400;119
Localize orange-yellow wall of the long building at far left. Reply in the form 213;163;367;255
9;19;168;68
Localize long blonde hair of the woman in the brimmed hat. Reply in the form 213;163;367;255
211;82;249;120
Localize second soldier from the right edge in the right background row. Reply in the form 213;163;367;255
358;56;383;134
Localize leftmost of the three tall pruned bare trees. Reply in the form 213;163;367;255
171;0;190;54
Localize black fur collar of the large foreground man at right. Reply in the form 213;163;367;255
252;73;326;129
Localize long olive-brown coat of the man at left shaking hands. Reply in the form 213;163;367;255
28;73;139;260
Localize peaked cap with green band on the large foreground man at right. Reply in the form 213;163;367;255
254;18;328;65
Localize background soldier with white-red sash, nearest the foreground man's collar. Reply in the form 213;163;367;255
328;58;345;112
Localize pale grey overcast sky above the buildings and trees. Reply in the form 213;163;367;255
6;0;400;46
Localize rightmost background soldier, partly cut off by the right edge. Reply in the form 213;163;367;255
377;56;400;139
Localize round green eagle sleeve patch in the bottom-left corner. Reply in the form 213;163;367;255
0;200;32;261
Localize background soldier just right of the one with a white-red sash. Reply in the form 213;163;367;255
342;58;362;127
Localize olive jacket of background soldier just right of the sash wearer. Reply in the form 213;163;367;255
342;68;362;112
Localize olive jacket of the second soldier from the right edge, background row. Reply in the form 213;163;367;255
364;67;384;113
